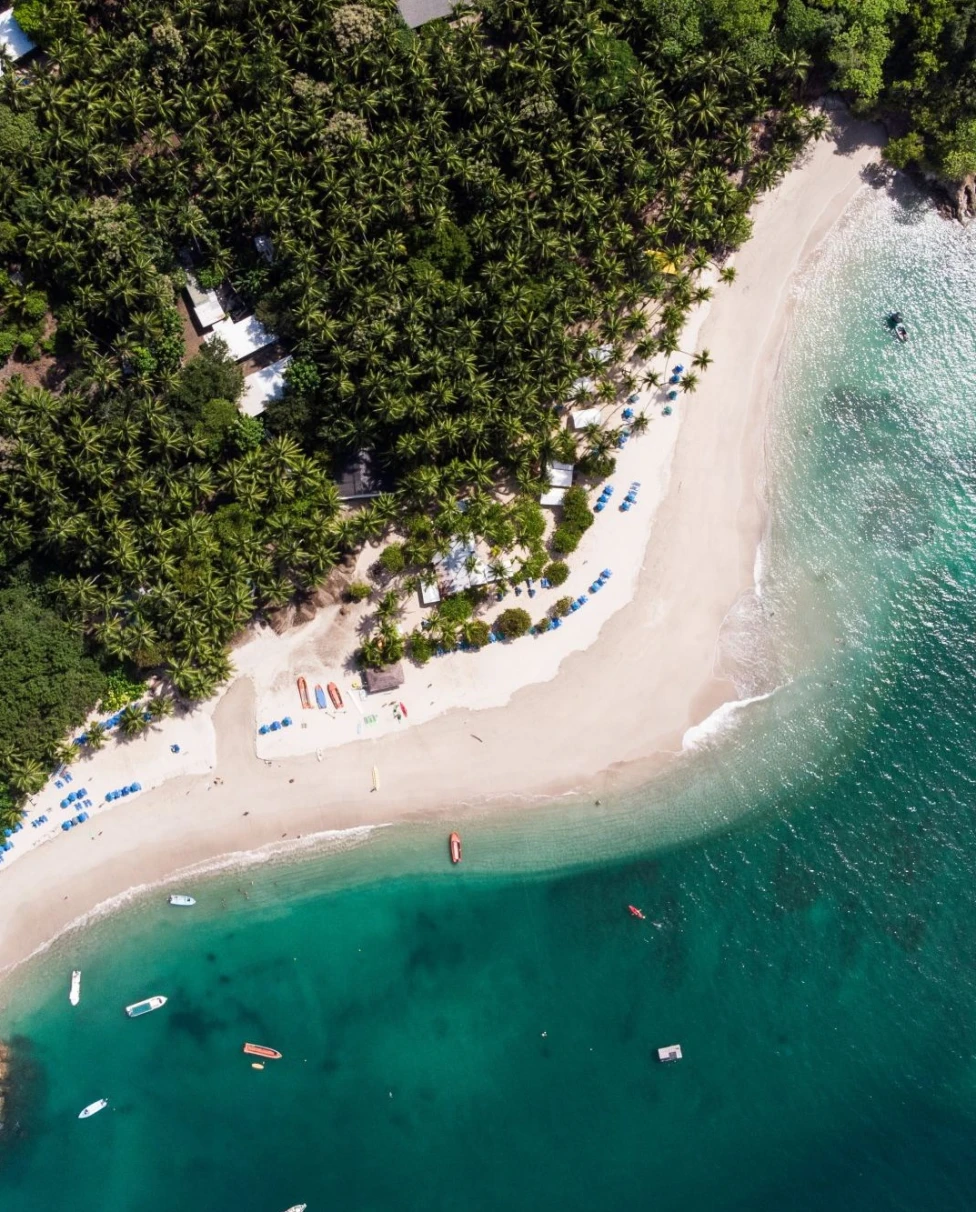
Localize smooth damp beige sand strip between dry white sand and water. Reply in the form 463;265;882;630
0;109;883;972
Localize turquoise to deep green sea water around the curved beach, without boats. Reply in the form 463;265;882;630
0;181;976;1212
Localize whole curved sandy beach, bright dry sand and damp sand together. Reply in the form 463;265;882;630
0;111;883;970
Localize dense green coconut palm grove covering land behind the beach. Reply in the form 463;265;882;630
0;0;877;799
